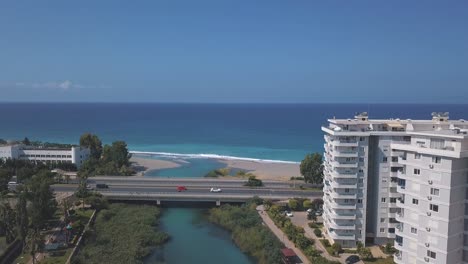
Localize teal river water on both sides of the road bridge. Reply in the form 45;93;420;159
145;159;255;264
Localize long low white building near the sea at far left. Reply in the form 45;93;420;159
0;145;90;168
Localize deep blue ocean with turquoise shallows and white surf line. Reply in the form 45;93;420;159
0;103;468;162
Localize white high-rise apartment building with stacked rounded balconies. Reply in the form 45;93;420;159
322;113;468;263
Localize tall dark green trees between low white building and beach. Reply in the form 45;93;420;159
80;133;135;177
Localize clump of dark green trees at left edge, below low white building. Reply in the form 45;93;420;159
0;165;57;263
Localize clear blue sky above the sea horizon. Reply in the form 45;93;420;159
0;0;468;103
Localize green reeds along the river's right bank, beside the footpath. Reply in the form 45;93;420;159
209;202;282;264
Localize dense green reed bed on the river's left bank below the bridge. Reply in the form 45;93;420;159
72;204;169;264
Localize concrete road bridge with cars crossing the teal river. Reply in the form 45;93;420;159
53;177;323;205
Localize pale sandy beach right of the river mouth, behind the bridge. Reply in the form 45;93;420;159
219;160;300;181
